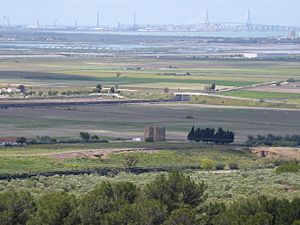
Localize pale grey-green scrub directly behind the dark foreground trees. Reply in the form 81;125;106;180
0;169;300;202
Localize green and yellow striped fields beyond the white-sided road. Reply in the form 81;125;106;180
0;57;300;90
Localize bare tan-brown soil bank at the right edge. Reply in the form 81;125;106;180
250;147;300;160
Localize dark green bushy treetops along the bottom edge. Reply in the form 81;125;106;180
0;172;300;225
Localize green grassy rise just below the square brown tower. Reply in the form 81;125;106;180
0;143;270;174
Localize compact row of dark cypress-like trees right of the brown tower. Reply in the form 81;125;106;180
187;126;235;144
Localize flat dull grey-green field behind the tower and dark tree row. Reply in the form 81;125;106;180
0;104;300;142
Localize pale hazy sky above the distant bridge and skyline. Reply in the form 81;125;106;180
0;0;300;26
